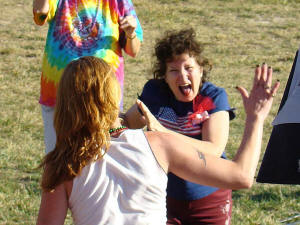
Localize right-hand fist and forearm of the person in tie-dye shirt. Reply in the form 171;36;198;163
120;15;141;57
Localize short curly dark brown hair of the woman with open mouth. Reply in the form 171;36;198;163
153;28;212;83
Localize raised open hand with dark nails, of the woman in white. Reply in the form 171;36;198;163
237;63;280;120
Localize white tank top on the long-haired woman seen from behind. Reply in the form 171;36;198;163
69;130;167;225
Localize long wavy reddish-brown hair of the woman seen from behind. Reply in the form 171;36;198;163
41;56;121;191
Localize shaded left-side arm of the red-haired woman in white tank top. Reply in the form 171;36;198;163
36;184;68;225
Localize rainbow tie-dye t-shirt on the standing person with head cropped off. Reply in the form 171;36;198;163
40;0;143;106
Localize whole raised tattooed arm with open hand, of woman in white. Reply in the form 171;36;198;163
147;65;279;189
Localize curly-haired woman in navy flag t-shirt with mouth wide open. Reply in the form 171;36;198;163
126;29;235;224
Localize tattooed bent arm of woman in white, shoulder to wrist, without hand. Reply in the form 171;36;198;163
147;118;262;189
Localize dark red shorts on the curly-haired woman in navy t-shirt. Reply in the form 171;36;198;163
167;189;232;225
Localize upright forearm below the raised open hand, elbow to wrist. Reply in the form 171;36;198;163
233;118;263;187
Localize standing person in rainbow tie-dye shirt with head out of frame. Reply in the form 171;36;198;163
33;0;143;153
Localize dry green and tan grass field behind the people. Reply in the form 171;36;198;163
0;0;300;225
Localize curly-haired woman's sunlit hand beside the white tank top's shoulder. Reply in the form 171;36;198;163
136;100;167;132
